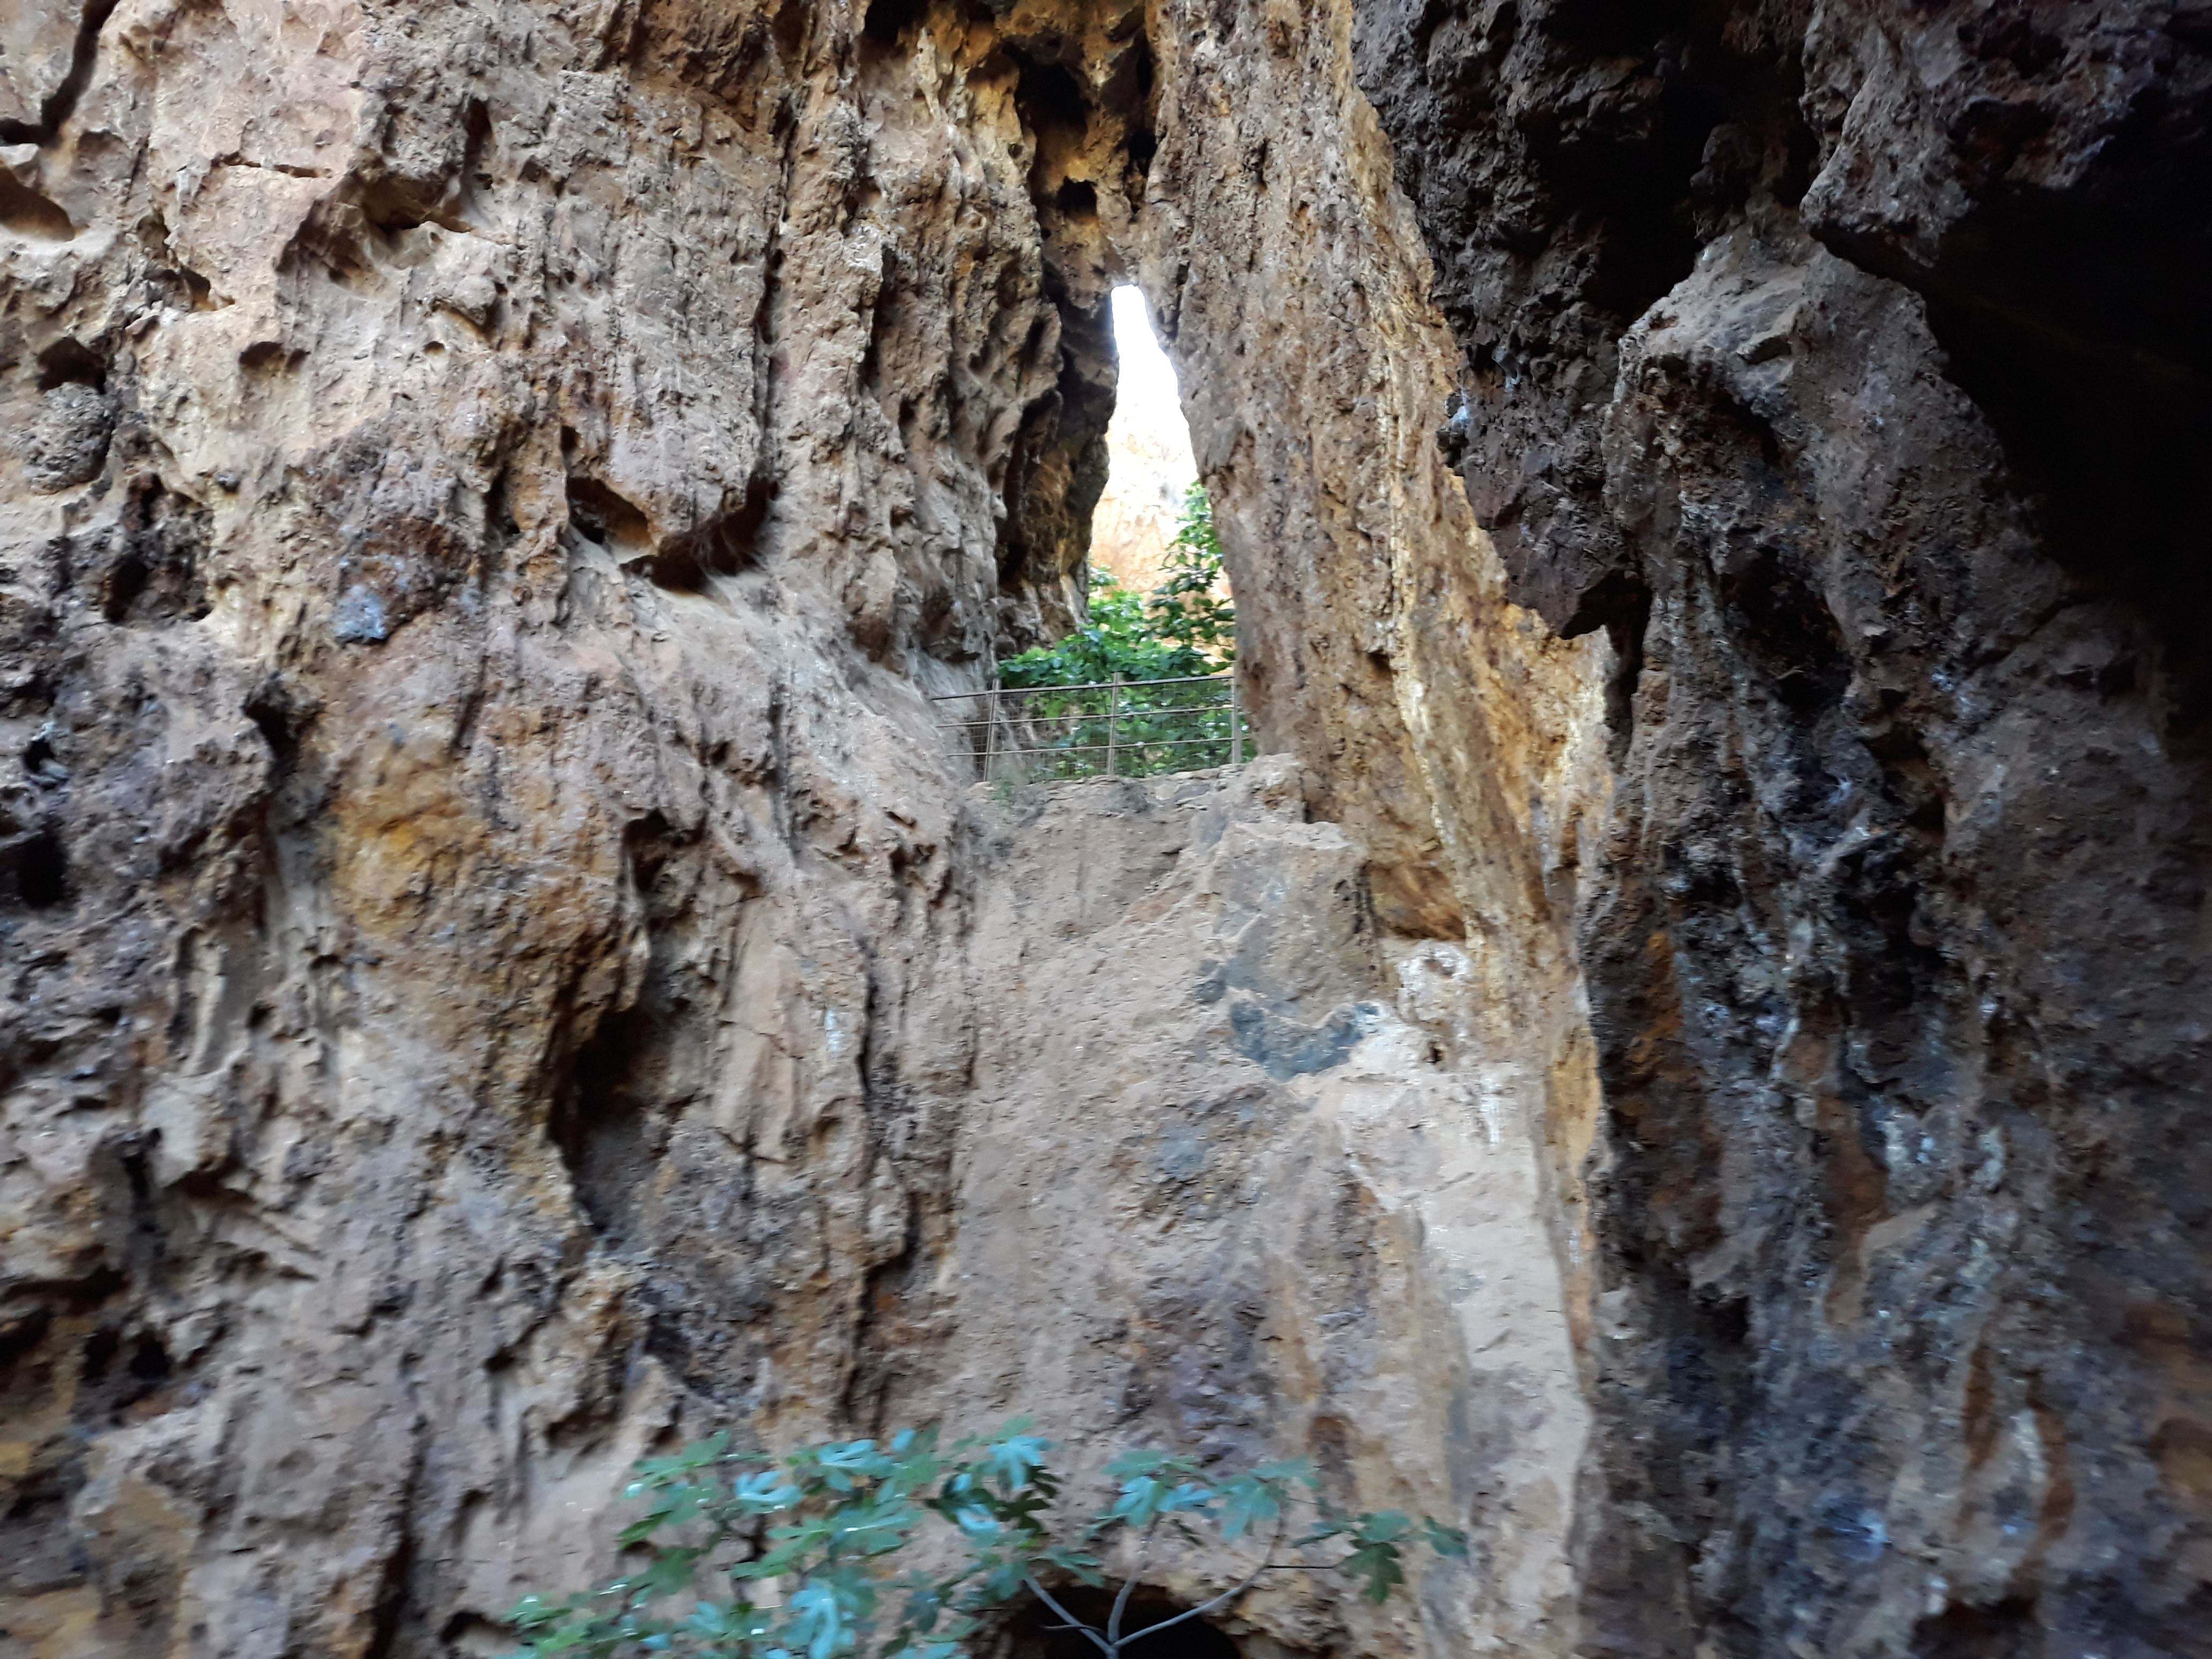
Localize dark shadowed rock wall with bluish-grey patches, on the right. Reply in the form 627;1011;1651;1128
1358;0;2212;1657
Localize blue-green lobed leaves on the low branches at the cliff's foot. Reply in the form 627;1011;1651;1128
509;1422;1467;1659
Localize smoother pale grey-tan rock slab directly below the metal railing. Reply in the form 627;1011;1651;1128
889;757;1582;1653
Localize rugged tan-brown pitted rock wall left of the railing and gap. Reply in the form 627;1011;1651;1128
0;0;1108;1655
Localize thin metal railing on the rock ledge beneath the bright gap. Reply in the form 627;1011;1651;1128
931;672;1252;783
